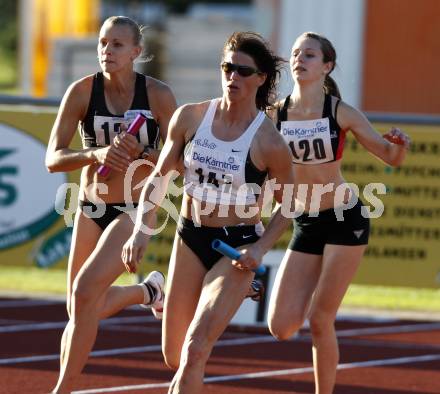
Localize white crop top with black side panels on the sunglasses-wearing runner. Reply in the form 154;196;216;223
184;99;267;205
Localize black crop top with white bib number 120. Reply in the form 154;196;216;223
277;94;346;164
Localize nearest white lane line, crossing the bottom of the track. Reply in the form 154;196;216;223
73;354;440;394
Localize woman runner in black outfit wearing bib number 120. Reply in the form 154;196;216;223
269;33;409;394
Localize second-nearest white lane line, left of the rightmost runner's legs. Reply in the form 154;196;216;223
0;335;276;365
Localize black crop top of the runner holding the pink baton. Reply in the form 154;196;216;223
80;72;160;149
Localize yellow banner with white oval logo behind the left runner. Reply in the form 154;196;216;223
0;106;74;267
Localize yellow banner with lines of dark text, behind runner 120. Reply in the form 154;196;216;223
342;124;440;288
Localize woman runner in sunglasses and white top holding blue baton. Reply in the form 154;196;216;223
123;32;293;394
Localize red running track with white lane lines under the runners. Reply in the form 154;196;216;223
0;298;440;394
